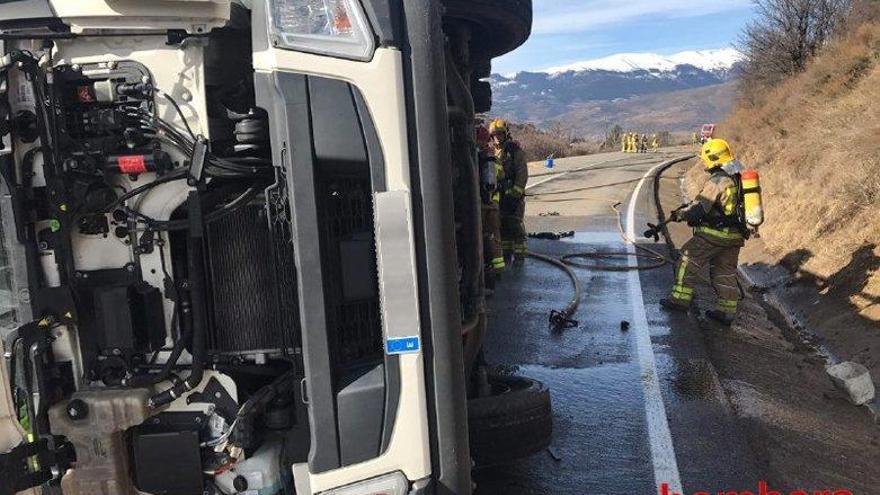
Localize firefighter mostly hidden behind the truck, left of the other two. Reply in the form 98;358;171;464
476;123;506;282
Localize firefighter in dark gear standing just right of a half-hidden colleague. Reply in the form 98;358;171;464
489;119;529;265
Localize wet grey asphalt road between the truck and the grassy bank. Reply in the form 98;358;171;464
475;149;760;495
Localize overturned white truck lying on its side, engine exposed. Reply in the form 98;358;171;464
0;0;536;495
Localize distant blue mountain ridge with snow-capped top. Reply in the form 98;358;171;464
489;49;742;135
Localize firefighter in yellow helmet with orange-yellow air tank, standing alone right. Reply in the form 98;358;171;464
660;139;749;326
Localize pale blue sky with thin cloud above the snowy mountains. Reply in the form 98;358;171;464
493;0;752;74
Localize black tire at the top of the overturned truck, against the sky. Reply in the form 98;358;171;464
444;0;532;59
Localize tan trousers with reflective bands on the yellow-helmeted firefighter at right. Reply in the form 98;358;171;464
672;235;742;313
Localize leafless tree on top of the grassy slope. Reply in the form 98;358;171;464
739;0;852;92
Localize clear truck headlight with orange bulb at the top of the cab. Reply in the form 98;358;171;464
269;0;375;60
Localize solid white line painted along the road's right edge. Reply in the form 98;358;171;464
626;163;683;493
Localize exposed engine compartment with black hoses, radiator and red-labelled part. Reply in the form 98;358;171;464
0;12;316;495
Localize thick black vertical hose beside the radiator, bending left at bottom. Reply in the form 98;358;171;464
150;190;208;408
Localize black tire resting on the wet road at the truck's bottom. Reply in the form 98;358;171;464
468;376;553;466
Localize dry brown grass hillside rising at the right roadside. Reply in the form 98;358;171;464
692;23;880;322
